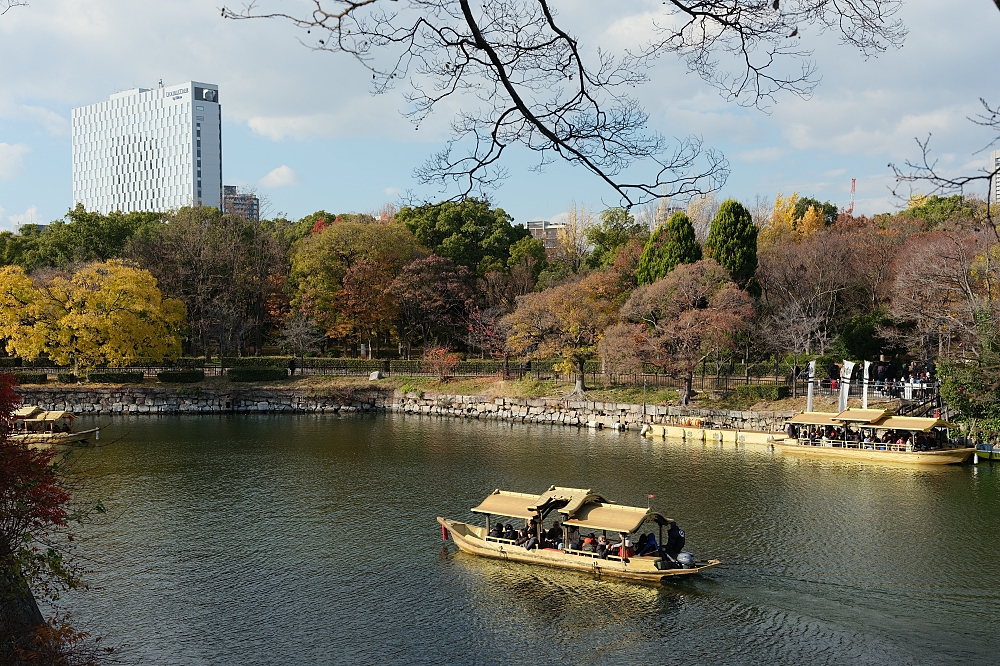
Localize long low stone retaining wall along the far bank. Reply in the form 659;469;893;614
13;386;791;432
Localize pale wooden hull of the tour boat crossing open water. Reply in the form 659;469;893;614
437;516;721;583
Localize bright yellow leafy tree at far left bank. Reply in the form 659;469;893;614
0;260;186;370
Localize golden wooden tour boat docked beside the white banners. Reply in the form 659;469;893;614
775;409;976;465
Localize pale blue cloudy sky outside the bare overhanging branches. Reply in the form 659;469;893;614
0;0;1000;230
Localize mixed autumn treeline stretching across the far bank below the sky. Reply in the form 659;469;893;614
0;194;1000;426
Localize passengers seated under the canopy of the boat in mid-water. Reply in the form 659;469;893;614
489;516;684;559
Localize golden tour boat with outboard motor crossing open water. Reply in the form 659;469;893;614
437;486;721;583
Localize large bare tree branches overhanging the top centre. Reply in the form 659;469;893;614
222;0;905;207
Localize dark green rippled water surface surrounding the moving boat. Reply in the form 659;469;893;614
67;416;1000;666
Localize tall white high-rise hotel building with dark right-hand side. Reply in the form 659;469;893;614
73;81;222;214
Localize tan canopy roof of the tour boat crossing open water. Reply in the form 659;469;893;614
472;486;673;532
